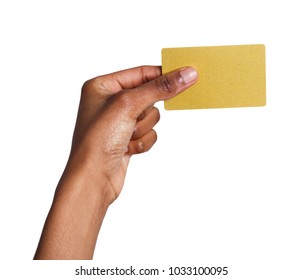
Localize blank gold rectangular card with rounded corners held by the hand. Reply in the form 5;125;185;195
162;45;266;110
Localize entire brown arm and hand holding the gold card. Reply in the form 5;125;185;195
34;66;198;259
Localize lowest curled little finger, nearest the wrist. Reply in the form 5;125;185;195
127;129;157;155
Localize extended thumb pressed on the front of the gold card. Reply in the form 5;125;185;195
119;67;198;118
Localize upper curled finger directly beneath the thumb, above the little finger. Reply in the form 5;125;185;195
131;107;160;140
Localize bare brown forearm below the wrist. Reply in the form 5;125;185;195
34;164;109;259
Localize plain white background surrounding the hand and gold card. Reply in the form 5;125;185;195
0;0;303;280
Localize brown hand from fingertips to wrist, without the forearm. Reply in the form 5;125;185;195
69;66;197;206
